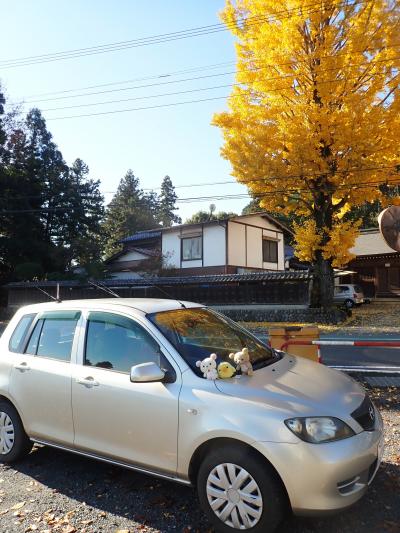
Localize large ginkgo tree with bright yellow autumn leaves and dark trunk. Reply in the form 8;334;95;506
213;0;400;307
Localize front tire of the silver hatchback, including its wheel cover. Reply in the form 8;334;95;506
197;446;288;533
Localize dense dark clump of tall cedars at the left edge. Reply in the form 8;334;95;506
0;102;103;279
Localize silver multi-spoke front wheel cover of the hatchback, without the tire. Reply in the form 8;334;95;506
206;463;263;530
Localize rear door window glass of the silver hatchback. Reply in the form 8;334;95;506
25;311;80;362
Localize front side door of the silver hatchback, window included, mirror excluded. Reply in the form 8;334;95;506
72;311;181;473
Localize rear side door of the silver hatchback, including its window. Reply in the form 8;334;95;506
9;311;80;446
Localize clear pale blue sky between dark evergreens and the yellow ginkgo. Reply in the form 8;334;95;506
0;0;247;219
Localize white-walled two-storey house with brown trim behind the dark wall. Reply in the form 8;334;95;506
106;213;290;279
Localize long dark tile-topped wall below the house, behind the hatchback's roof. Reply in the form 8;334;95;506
5;271;311;310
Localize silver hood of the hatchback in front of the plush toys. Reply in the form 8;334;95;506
215;354;365;420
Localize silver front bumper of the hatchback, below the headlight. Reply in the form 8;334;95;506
253;411;384;515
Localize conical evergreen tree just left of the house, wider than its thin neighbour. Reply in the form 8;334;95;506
103;170;159;257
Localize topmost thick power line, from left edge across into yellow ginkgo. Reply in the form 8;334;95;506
0;0;364;68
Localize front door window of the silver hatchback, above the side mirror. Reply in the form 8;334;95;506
84;311;163;373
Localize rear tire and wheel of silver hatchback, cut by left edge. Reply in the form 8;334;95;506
0;401;33;463
